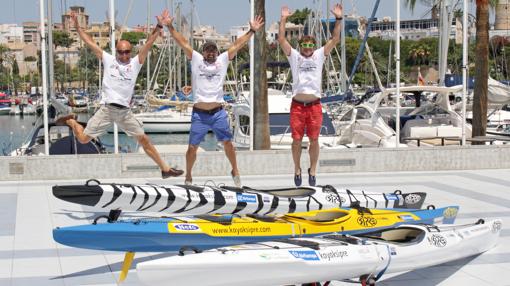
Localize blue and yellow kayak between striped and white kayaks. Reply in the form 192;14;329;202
53;206;458;252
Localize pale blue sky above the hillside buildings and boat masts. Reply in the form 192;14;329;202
0;0;472;33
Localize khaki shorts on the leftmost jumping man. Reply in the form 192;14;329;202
84;105;145;138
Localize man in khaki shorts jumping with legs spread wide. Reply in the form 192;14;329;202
55;10;184;179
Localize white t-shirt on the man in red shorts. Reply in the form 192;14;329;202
288;47;325;98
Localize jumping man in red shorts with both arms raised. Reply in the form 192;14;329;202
278;4;343;186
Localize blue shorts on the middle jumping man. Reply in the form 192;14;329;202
189;109;232;146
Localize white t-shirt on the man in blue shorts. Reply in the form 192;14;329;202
191;51;229;103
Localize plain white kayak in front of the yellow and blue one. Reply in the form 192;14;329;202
136;219;502;286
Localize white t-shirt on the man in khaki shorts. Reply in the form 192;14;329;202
101;51;142;106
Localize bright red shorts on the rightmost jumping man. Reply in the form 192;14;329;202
290;101;322;140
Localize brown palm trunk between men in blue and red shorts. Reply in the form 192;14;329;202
254;0;271;150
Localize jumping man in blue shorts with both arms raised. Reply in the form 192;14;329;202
164;13;264;187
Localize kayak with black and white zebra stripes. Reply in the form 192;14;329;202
53;180;426;216
